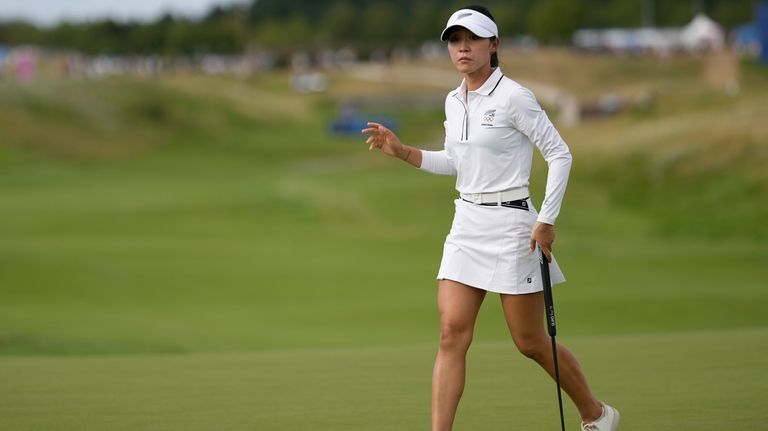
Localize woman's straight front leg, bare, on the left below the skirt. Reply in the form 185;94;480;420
432;280;485;431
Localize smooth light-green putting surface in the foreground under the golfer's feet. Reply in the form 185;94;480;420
0;329;768;431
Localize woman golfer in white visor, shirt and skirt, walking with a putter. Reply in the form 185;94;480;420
362;6;619;431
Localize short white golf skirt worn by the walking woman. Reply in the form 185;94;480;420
437;199;565;295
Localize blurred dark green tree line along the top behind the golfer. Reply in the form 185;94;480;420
0;0;756;57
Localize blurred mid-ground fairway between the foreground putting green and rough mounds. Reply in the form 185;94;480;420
0;155;768;354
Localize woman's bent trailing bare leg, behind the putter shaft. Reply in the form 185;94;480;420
501;292;602;422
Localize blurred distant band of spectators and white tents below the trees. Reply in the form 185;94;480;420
0;10;762;86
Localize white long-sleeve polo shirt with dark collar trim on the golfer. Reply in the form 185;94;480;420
420;68;572;224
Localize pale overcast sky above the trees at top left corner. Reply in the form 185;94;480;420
0;0;249;25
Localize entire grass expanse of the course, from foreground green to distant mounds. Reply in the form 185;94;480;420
0;52;768;431
